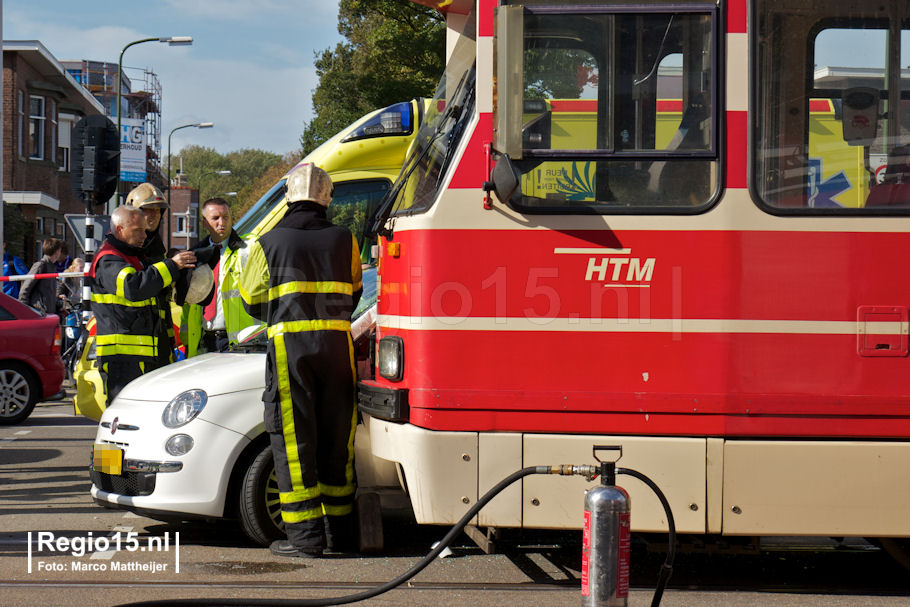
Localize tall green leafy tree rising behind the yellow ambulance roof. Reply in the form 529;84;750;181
300;0;446;155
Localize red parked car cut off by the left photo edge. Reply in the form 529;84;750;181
0;293;63;425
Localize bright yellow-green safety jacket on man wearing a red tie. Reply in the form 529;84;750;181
178;230;258;358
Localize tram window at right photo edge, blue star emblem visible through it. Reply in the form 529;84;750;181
751;0;910;214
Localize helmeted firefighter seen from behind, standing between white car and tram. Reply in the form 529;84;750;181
239;164;363;557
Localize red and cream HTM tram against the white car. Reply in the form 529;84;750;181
360;0;910;556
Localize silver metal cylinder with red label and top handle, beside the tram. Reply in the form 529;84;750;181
581;446;632;607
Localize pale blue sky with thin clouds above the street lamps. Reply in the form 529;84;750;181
2;0;341;154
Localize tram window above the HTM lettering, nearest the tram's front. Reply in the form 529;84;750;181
498;0;718;213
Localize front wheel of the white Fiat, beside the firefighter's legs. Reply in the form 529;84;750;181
239;443;285;546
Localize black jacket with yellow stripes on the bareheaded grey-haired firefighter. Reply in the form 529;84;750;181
89;234;178;371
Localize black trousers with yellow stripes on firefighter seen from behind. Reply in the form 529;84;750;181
263;331;357;551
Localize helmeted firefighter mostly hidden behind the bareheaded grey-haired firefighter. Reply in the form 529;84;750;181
124;183;177;366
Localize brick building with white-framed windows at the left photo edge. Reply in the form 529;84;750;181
3;40;104;264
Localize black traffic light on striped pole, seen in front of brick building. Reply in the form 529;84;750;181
70;114;120;204
